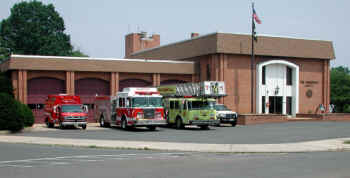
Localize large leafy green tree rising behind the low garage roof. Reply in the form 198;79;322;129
0;0;73;56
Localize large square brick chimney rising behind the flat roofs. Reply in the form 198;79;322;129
125;32;160;58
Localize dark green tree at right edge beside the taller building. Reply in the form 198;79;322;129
330;66;350;112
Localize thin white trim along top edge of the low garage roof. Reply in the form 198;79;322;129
11;54;194;64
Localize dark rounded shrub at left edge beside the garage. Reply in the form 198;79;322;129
0;93;24;132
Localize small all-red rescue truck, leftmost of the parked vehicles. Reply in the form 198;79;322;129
44;94;88;129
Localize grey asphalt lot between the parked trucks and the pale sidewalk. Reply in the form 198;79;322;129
16;122;350;144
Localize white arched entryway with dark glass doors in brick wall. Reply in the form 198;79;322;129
256;60;299;116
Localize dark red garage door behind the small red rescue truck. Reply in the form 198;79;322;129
27;77;66;123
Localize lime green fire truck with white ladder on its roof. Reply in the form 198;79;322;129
158;81;226;129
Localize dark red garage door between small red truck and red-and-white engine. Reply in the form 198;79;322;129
75;78;110;122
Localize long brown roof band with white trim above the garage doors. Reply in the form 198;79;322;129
0;55;195;74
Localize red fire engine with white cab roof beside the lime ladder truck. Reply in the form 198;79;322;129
94;87;166;130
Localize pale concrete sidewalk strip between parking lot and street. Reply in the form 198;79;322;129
0;135;350;153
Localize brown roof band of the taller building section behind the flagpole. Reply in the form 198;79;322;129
131;32;335;60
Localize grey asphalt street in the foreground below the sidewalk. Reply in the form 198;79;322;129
0;143;350;178
